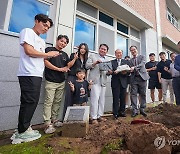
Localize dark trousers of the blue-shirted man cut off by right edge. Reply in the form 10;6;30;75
172;77;180;105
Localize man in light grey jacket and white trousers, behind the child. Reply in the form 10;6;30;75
86;44;109;124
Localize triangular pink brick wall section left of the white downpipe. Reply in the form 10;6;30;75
122;0;156;29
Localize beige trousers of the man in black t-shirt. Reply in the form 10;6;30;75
43;80;65;125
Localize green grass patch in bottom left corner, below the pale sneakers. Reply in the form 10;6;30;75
0;135;53;154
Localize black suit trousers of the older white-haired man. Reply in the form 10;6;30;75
112;83;126;115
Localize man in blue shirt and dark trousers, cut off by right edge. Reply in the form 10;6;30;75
173;41;180;105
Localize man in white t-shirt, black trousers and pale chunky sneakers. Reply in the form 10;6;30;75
11;14;59;144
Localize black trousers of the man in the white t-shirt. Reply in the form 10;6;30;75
18;76;42;133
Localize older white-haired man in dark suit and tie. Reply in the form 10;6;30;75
110;49;128;119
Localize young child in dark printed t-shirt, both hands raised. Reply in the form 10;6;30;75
68;69;92;106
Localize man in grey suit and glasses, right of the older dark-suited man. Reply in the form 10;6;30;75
129;46;149;117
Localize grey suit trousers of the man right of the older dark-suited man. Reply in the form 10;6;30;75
130;76;147;113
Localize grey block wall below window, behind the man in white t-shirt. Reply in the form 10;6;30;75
0;33;54;131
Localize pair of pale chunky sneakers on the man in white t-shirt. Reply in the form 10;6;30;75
11;129;41;144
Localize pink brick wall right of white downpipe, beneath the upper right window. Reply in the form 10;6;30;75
159;0;180;42
